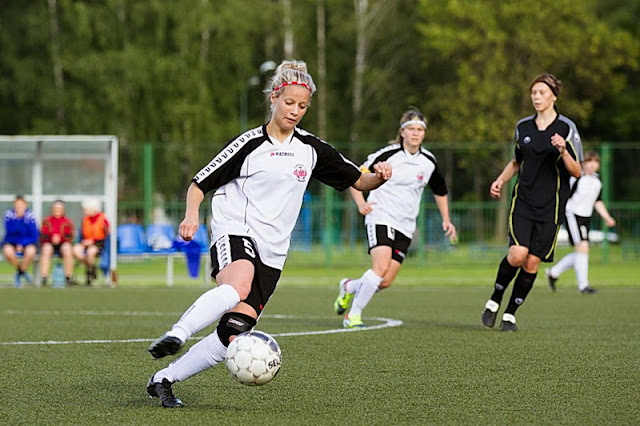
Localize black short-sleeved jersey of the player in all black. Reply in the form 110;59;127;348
511;114;582;224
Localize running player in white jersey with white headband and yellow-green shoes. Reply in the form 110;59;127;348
334;109;457;328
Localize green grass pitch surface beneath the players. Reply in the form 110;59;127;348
0;245;640;425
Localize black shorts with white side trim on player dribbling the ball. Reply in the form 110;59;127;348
211;235;282;315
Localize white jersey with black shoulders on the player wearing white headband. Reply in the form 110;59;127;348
363;143;448;238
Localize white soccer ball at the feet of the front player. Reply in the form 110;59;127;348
225;330;282;386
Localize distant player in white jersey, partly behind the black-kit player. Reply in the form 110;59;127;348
545;151;616;294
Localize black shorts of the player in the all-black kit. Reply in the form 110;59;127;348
509;215;560;262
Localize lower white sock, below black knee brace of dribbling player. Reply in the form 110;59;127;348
153;330;227;383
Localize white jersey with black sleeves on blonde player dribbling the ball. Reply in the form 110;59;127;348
193;125;361;269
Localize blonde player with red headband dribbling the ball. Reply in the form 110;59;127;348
147;61;391;408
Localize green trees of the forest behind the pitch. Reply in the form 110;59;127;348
0;0;640;200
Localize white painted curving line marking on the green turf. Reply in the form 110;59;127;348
0;310;402;346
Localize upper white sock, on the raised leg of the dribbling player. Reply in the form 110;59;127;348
167;284;240;343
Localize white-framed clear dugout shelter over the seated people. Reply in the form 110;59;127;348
0;135;118;284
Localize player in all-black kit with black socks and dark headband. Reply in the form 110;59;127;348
482;74;582;331
